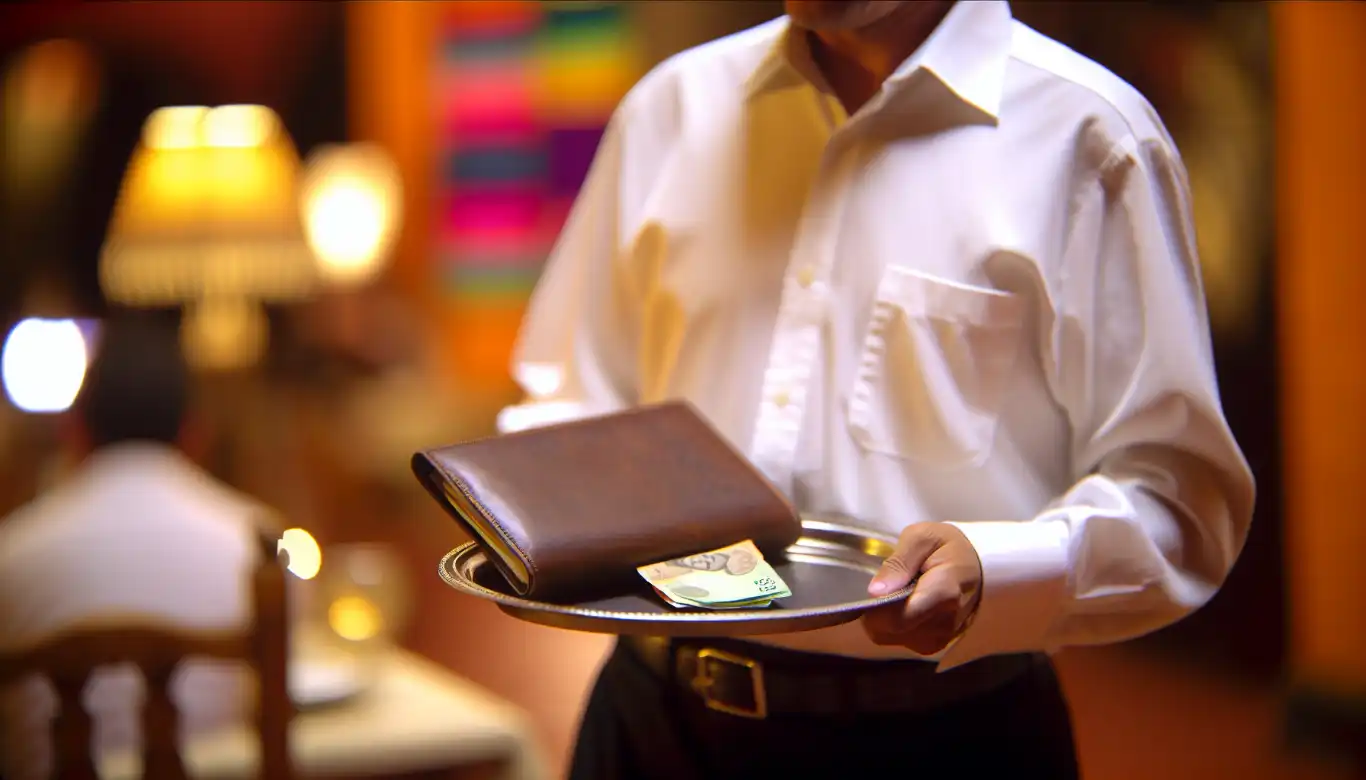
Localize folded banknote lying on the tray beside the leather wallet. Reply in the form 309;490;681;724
637;540;792;609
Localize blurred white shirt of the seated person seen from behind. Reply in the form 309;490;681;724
0;444;269;780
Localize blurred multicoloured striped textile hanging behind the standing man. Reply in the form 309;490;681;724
434;0;638;382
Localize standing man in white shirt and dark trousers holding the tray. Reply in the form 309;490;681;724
500;0;1254;780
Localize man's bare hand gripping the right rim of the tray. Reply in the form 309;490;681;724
863;523;982;656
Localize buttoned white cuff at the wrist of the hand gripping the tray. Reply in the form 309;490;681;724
938;520;1070;672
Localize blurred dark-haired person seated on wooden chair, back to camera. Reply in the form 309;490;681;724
0;317;275;780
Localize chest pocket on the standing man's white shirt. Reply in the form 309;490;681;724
848;268;1025;467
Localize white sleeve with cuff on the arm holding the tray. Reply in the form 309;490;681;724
940;139;1254;669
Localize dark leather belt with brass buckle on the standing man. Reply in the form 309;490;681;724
620;637;1046;719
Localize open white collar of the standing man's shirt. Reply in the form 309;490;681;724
747;0;1012;120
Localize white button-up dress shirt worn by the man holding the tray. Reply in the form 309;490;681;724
500;1;1254;668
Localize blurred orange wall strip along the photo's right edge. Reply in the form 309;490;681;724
1272;1;1366;693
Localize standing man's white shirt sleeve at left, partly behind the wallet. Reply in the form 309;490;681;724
499;115;638;433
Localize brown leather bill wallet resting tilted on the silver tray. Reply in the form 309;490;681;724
413;402;802;602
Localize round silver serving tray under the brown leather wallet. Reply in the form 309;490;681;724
438;519;911;637
